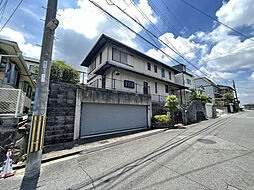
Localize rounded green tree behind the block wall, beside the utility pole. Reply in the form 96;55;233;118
33;61;80;84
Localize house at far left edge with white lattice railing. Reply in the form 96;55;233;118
0;39;35;116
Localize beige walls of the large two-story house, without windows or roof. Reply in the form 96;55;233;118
88;45;184;99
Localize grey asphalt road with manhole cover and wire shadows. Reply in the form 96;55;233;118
0;111;254;190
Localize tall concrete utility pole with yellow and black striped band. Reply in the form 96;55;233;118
25;0;59;177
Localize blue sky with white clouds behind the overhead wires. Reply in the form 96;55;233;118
0;0;254;104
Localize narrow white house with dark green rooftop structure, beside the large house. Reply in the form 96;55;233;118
173;64;195;104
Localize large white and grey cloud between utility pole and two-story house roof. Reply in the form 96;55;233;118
54;0;157;69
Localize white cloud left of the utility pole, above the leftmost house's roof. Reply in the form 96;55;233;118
0;28;41;58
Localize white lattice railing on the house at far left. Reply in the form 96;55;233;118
0;88;31;117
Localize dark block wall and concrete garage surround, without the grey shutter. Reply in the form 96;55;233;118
45;82;152;146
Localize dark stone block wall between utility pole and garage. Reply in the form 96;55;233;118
44;83;79;145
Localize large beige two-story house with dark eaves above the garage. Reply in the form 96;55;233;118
81;35;187;107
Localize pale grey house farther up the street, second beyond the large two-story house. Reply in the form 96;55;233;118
194;77;220;103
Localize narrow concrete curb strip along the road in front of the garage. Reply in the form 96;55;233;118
13;129;167;170
